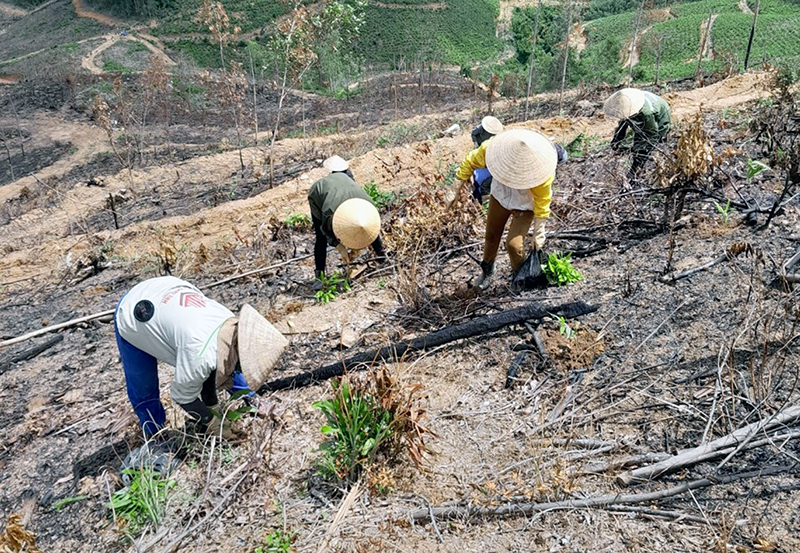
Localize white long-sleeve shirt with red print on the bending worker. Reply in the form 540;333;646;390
116;276;234;404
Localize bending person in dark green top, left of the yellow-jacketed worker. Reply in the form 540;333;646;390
308;156;386;286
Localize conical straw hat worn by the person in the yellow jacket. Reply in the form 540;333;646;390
486;129;558;190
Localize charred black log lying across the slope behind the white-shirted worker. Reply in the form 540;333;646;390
258;301;598;394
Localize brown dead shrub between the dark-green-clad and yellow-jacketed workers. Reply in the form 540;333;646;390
386;188;482;311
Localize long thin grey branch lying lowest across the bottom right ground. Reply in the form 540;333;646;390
408;463;797;522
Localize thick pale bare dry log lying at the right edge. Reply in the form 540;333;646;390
617;405;800;486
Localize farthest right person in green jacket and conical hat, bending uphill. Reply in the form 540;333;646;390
603;88;672;178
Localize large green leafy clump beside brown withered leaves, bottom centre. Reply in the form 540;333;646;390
314;379;392;480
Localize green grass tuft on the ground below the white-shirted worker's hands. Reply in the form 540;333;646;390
108;467;175;529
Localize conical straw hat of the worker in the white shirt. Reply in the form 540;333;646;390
238;304;289;390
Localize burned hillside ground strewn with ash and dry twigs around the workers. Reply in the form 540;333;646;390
0;70;800;552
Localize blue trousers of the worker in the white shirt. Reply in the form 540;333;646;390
114;300;250;438
